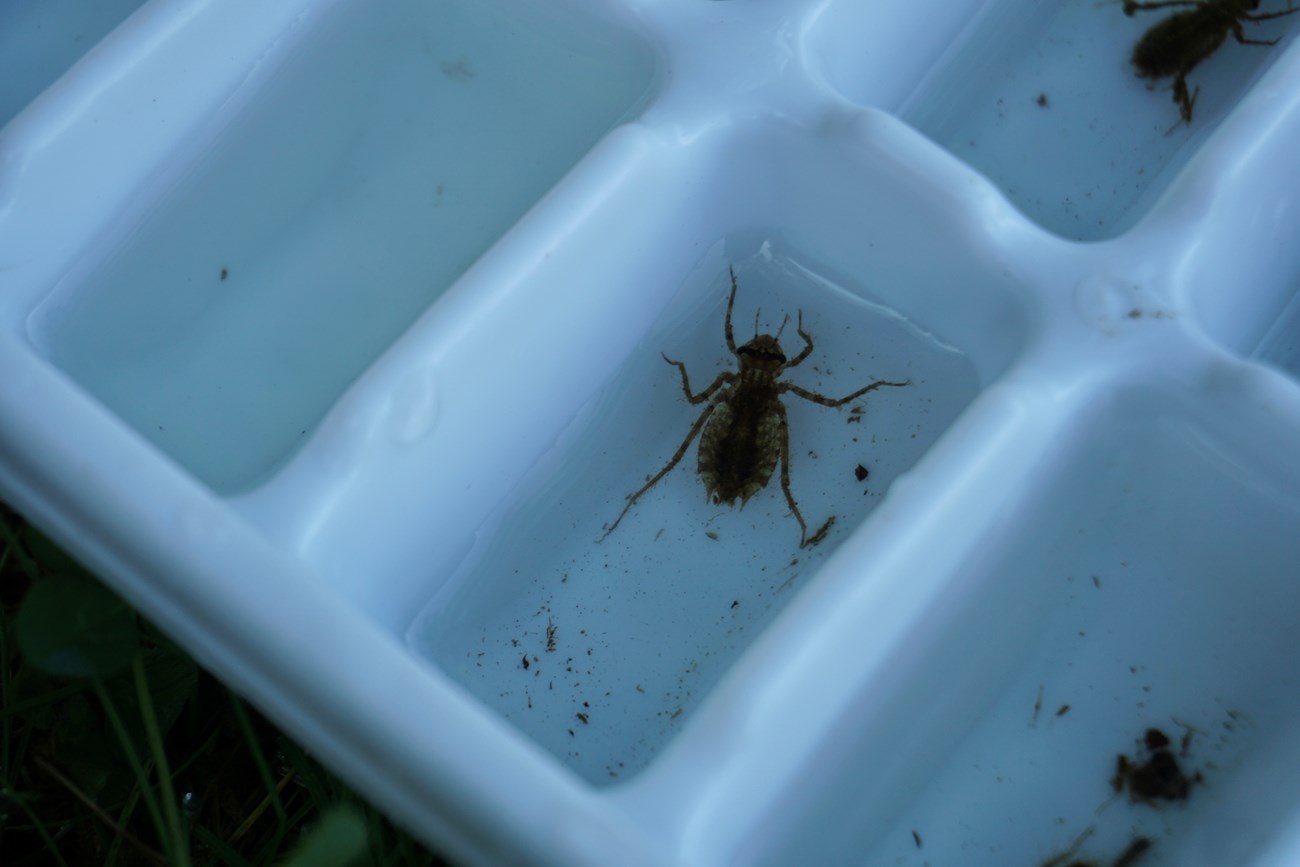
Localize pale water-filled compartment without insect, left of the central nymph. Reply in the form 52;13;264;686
17;3;650;493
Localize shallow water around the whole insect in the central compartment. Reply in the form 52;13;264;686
411;246;978;783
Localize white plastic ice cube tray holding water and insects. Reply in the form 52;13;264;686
0;0;1300;867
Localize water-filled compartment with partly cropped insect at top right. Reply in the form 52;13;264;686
898;0;1300;240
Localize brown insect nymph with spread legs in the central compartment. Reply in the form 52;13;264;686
598;269;911;547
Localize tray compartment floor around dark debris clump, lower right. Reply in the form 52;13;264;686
751;374;1300;864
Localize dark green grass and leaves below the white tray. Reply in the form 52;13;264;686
0;504;446;867
